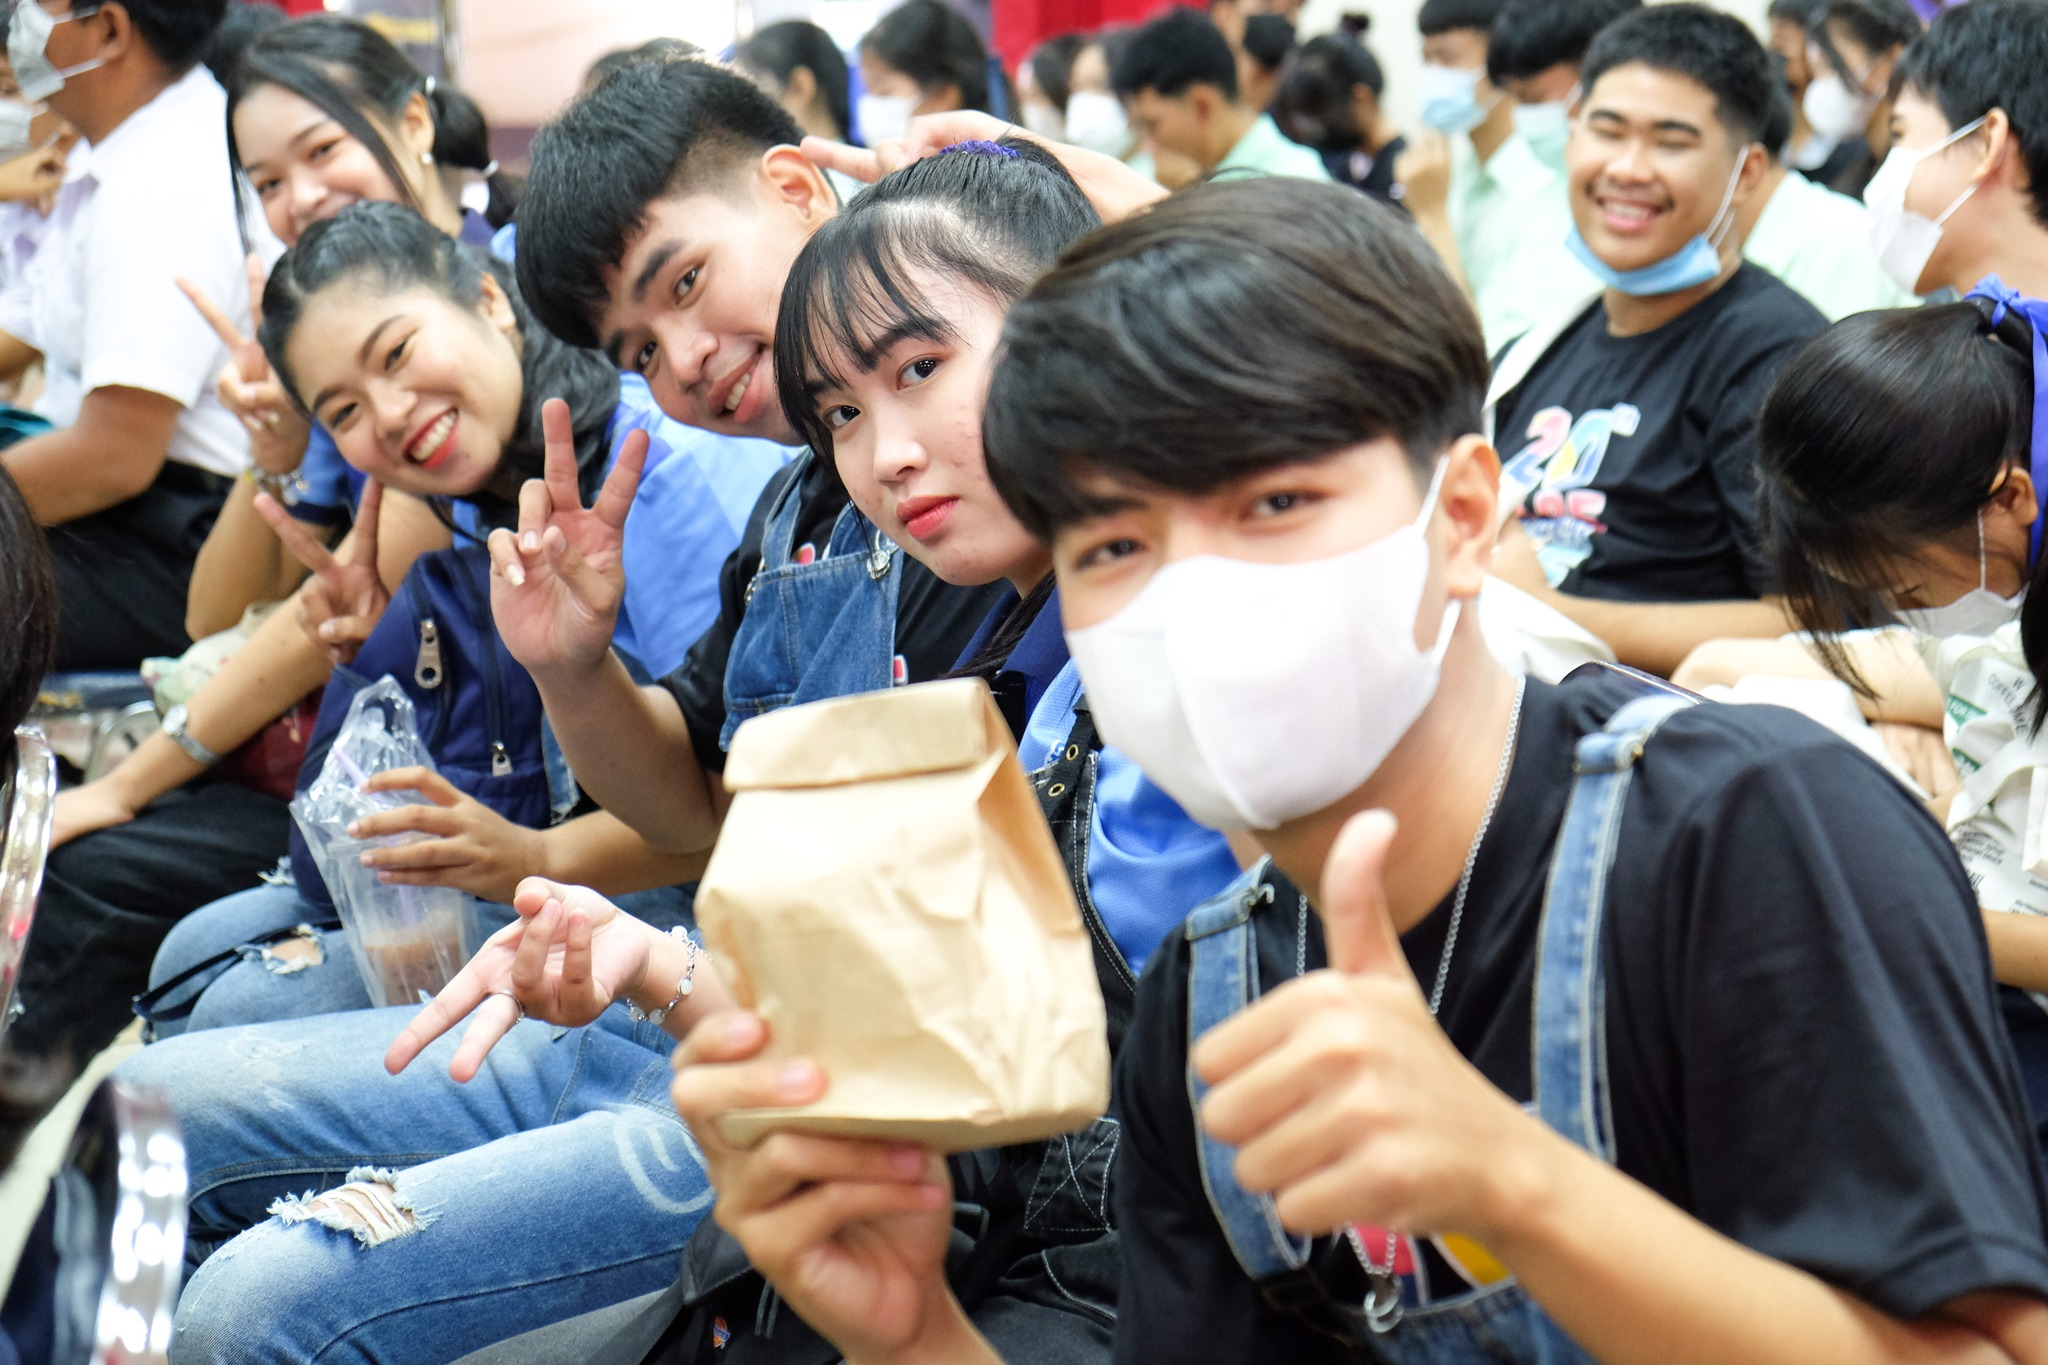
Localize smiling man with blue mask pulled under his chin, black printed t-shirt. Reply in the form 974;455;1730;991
1491;4;1825;673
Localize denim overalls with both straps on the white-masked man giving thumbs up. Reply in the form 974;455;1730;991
1184;694;1688;1365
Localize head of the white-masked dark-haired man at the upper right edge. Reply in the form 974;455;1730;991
1864;0;2048;299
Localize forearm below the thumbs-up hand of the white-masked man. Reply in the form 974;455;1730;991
1481;1130;2048;1365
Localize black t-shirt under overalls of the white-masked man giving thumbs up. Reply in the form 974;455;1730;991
1116;679;2048;1365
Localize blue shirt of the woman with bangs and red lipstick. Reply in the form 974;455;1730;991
961;591;1239;972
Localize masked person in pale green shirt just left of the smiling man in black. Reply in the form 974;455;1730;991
1395;0;1605;350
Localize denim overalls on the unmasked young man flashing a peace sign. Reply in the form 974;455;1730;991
719;450;903;749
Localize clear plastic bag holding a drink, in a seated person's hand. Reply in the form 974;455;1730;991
291;677;477;1007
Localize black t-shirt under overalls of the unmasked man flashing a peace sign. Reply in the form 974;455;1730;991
662;458;1008;772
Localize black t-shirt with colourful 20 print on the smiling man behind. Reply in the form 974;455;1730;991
1493;264;1827;602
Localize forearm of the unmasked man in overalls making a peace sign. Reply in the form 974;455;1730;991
532;653;719;853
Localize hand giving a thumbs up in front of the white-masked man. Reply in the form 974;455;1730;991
1190;810;1548;1240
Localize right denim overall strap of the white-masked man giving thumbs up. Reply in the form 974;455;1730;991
1530;694;1694;1164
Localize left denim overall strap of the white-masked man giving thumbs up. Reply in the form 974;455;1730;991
1182;860;1309;1281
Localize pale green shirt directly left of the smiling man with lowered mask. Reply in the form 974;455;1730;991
1444;133;1599;352
